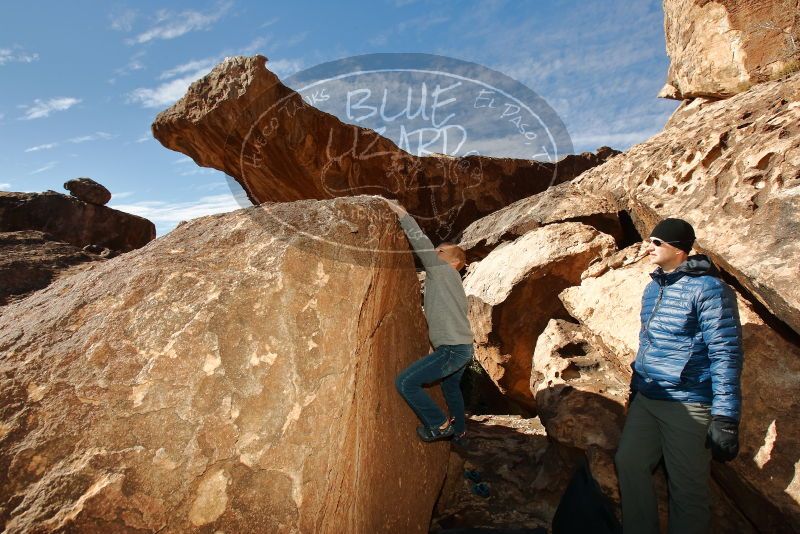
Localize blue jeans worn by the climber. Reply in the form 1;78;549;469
395;344;474;434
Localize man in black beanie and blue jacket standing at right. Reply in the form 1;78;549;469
616;219;742;534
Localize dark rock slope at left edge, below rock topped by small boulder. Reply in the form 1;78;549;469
0;230;102;306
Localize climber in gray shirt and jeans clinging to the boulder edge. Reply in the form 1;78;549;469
386;200;474;443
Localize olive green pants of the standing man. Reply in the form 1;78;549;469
616;394;711;534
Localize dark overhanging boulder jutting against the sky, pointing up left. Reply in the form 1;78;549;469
152;56;615;240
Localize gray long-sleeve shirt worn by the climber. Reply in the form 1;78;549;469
400;214;473;348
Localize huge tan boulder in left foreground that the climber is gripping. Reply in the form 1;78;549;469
0;197;448;533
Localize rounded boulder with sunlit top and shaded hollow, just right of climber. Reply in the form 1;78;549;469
464;222;615;411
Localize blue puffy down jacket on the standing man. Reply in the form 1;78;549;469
631;255;742;420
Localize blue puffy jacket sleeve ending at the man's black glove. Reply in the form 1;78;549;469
697;278;743;421
